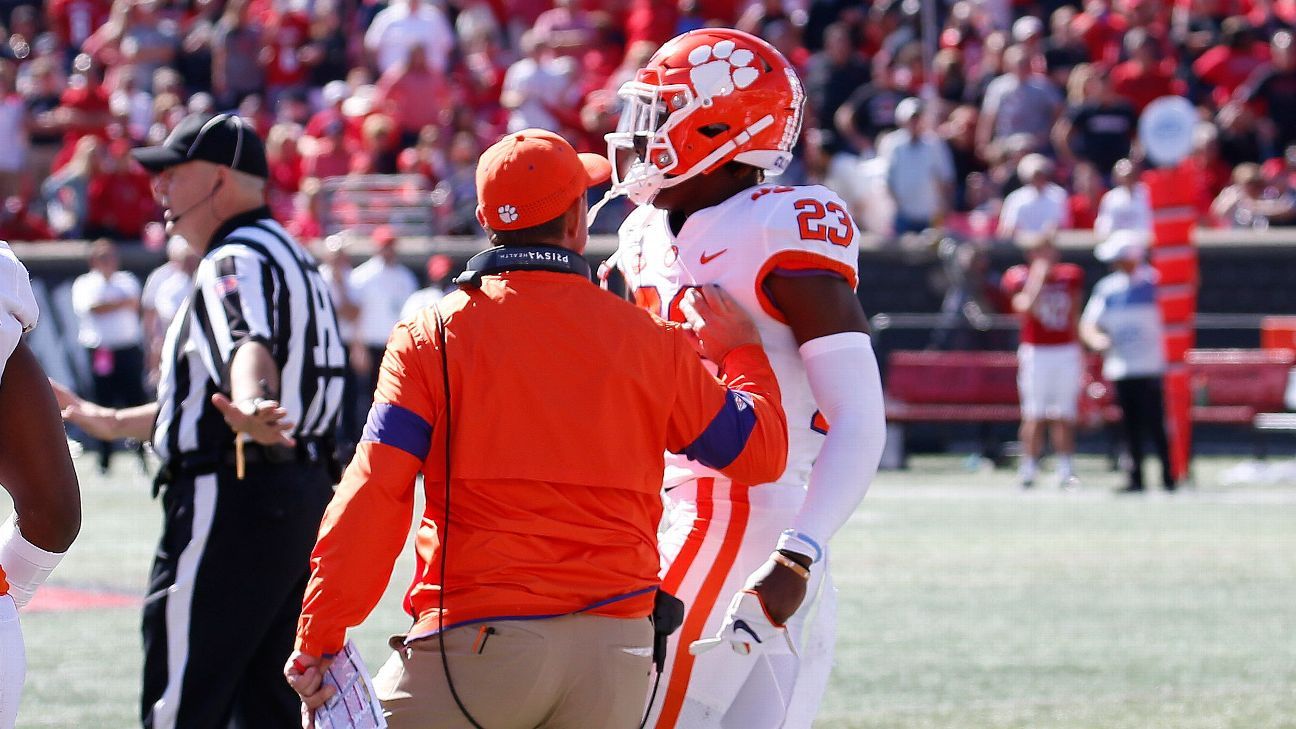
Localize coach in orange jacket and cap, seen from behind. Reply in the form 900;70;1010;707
286;130;787;729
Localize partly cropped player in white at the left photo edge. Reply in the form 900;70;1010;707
0;241;80;729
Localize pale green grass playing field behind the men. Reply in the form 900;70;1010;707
0;457;1296;729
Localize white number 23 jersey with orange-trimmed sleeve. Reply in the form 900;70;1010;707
618;184;859;489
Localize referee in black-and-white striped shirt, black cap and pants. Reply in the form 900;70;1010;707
60;108;346;729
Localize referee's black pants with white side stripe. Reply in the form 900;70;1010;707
141;463;333;729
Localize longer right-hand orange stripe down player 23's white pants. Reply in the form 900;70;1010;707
657;481;752;729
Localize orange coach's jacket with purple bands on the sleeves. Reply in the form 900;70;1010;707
297;271;788;655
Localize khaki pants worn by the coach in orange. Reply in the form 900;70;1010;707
373;615;652;729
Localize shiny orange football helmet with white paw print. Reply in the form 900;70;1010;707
607;29;805;205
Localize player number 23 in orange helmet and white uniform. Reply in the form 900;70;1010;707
607;29;885;729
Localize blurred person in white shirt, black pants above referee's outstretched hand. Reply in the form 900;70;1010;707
73;240;146;473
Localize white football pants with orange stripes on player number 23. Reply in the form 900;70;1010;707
648;477;836;729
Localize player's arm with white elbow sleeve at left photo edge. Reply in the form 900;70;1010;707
0;342;80;607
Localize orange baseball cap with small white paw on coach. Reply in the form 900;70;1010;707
477;130;612;231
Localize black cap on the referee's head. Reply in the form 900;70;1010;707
131;114;270;178
